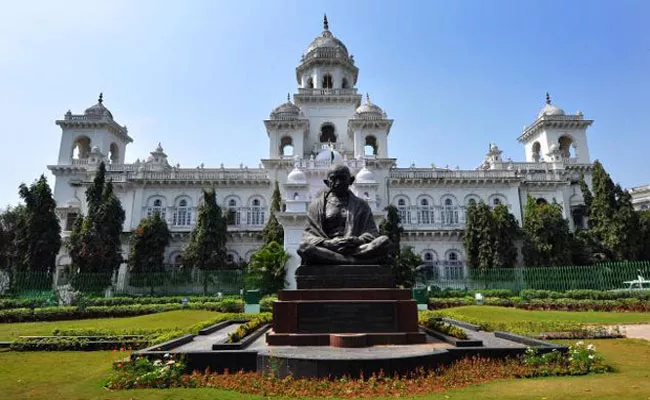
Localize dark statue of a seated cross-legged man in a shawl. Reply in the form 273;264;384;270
298;165;393;265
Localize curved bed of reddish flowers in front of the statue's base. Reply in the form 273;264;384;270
106;343;610;398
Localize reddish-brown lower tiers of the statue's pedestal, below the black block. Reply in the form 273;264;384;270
266;289;425;347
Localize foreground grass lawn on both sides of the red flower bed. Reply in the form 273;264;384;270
0;339;650;400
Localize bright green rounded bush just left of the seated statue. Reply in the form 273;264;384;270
248;242;290;295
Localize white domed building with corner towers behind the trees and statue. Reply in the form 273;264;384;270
48;19;593;284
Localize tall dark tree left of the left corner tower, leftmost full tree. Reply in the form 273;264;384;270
18;175;61;272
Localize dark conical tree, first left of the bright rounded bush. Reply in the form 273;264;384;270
183;189;227;270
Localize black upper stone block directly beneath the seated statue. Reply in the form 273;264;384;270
296;265;394;289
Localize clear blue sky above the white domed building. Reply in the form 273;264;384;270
0;0;650;206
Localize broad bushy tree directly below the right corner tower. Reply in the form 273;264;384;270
523;196;571;267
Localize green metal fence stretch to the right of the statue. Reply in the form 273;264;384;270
420;261;650;291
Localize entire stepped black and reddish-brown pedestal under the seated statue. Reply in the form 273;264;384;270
266;265;426;347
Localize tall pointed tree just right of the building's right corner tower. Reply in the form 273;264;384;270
580;160;646;260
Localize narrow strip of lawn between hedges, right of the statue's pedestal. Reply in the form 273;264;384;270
441;306;650;324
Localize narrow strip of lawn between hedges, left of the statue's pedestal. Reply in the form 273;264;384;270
0;310;219;340
